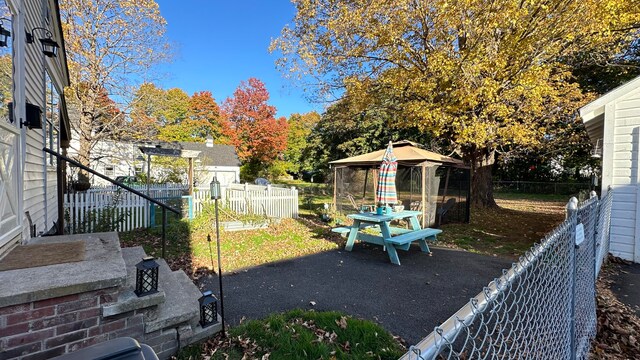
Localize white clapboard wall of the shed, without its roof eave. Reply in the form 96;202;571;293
605;89;640;261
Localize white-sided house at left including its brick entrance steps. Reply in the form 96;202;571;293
0;0;221;360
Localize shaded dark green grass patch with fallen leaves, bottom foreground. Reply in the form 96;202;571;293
177;310;406;360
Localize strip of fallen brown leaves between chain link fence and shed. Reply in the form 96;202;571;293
591;256;640;360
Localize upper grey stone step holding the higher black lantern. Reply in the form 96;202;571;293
102;246;165;317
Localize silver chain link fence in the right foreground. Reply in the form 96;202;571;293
401;190;613;360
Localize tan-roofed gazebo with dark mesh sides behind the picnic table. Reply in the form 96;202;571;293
329;140;470;227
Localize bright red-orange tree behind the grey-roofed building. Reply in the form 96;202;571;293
222;78;288;165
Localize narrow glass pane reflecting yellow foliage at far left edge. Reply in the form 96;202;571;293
0;0;15;123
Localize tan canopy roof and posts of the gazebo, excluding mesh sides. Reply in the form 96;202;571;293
329;140;470;227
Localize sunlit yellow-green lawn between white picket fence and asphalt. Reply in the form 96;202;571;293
120;204;344;277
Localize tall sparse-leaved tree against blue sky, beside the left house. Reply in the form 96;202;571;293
60;0;169;165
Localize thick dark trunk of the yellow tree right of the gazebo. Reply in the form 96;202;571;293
470;150;498;208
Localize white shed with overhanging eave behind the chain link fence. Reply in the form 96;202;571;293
580;77;640;262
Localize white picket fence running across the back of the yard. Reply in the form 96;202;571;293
64;184;298;234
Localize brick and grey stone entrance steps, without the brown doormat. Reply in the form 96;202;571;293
0;233;221;360
